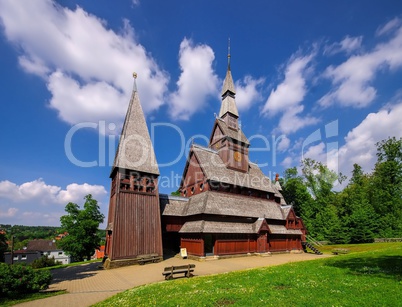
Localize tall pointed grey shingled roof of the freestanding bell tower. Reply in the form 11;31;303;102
112;76;159;175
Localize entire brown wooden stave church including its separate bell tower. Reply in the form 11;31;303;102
104;55;306;268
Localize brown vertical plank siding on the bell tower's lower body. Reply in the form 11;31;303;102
109;192;163;260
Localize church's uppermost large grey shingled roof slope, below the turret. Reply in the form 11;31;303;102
191;145;274;193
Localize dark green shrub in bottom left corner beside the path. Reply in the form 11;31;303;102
0;263;52;298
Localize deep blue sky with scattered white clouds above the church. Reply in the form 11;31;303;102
0;0;402;226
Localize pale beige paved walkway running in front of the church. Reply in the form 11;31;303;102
18;253;329;307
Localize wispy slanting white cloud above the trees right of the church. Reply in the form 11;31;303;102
262;54;318;133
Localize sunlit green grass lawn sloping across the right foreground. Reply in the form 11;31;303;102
96;243;402;306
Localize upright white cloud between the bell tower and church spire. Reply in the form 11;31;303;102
169;38;218;120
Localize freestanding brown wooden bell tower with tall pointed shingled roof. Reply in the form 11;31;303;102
104;73;163;268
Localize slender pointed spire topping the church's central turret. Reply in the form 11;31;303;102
219;39;239;118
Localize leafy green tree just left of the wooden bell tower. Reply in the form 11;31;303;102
59;194;104;261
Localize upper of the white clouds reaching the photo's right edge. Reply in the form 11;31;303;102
319;19;402;108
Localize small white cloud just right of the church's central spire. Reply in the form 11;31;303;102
236;76;265;111
